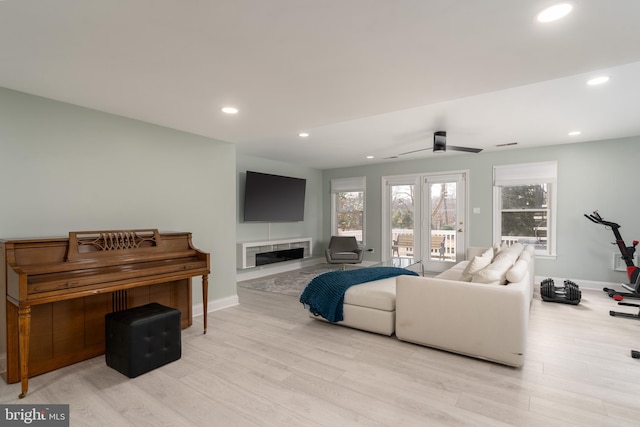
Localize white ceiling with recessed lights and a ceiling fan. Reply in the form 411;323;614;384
0;0;640;169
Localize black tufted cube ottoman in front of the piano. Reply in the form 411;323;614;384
105;303;182;378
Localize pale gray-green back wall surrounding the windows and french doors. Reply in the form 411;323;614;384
323;137;640;283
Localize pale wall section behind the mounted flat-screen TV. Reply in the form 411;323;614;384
236;153;323;256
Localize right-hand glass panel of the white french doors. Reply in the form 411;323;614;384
422;172;467;272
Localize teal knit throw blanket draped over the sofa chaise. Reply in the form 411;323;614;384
300;267;418;322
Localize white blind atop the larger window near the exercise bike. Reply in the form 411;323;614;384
493;162;558;187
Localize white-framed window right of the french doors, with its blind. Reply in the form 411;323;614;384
493;162;557;256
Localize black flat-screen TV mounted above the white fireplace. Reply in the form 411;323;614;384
244;171;307;222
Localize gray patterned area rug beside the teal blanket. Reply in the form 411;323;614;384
238;264;340;297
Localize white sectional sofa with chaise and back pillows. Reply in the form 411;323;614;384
311;243;534;367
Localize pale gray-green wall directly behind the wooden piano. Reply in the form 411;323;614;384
0;88;236;352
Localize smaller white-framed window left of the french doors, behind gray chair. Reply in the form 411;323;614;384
331;177;366;244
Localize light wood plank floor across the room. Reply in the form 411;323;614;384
0;282;640;427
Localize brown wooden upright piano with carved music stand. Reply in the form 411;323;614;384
0;229;209;398
